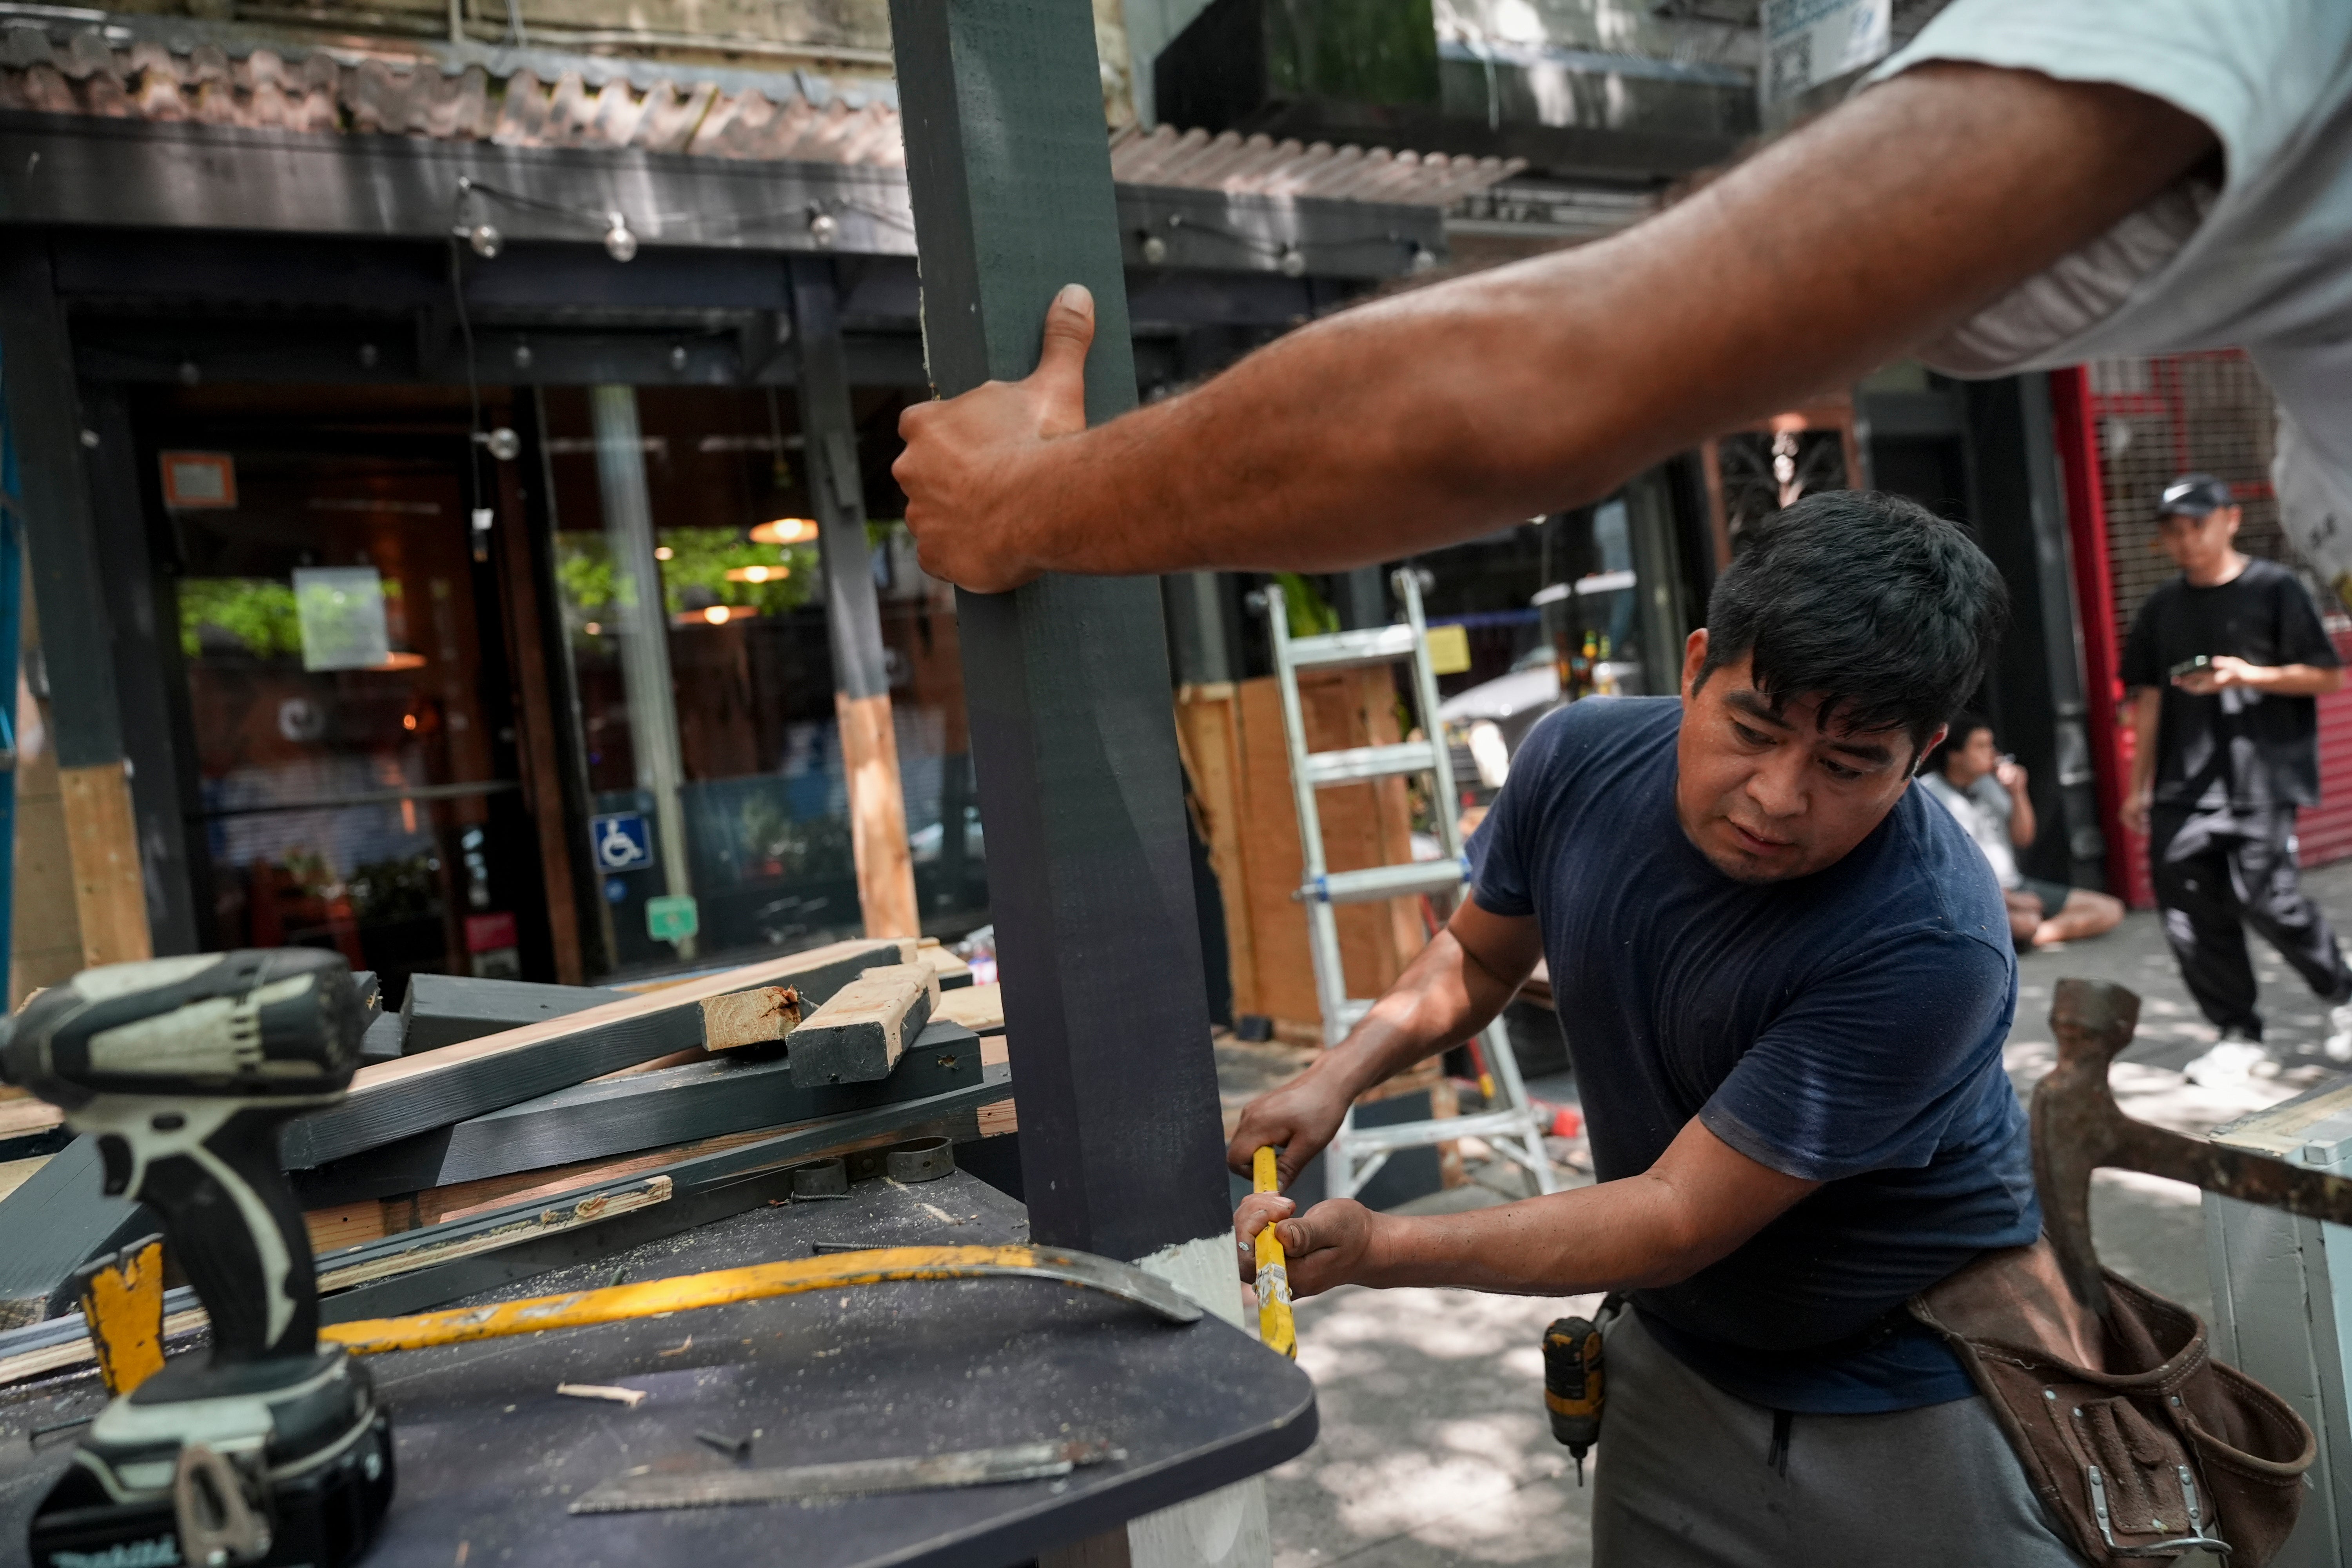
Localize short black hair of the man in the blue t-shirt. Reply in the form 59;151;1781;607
1693;489;2009;752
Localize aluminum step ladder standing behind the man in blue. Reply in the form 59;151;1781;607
1263;569;1557;1199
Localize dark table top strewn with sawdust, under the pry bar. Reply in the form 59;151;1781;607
0;1171;1315;1568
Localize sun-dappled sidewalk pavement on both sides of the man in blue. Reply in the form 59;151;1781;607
1268;863;2352;1568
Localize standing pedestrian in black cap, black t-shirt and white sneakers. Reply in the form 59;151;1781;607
2124;472;2352;1082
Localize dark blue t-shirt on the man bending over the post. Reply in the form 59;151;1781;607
1470;698;2042;1413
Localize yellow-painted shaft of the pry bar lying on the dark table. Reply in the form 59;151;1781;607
318;1246;1042;1356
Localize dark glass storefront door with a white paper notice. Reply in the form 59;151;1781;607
141;388;553;999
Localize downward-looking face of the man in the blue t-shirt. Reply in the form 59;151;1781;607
1675;630;1940;882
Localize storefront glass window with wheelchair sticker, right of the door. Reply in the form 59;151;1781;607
543;386;985;973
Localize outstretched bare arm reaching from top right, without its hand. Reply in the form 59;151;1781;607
974;68;2211;573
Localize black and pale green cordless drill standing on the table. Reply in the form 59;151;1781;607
0;947;393;1568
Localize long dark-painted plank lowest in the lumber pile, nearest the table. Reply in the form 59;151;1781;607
320;1067;1011;1323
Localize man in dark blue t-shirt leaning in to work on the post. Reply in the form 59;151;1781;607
1230;491;2074;1568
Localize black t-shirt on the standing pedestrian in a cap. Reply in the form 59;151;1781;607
2124;557;2343;811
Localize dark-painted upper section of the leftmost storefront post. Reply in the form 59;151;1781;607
0;230;122;769
